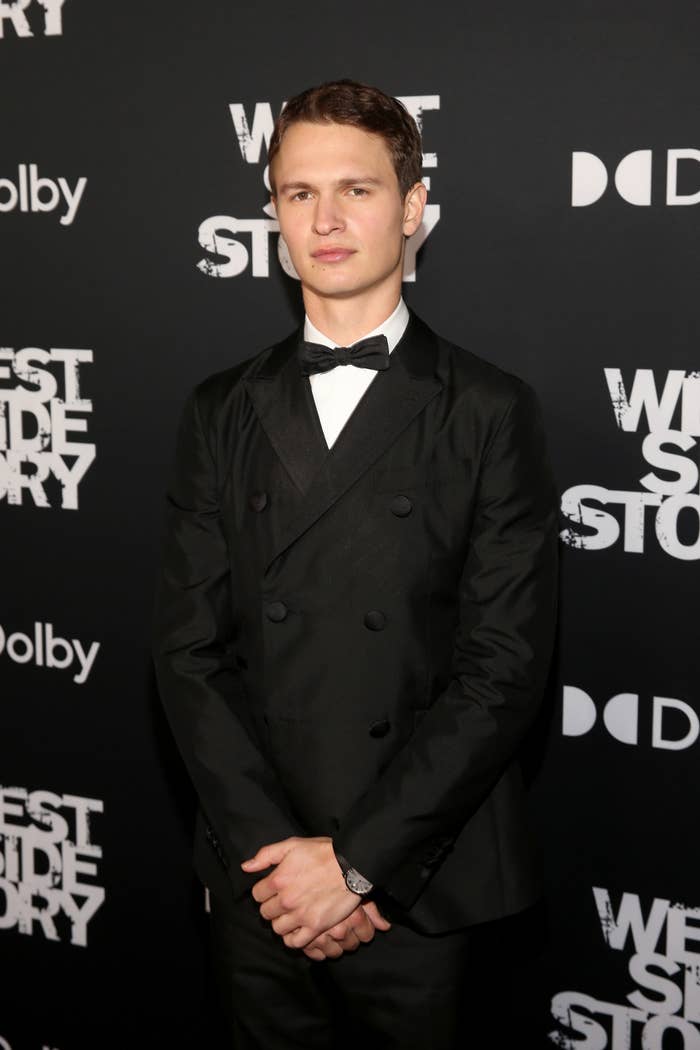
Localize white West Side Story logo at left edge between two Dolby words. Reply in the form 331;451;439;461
0;347;96;510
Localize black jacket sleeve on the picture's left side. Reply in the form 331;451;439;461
153;391;304;890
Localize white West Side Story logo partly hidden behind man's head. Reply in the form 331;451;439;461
197;95;440;281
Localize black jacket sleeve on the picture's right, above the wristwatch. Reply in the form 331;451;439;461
334;381;558;908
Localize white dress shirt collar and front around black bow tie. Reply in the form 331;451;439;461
303;299;409;448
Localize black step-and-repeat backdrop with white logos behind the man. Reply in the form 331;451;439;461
0;0;700;1050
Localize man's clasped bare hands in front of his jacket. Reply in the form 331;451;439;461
240;836;391;961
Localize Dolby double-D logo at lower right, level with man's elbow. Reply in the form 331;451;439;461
561;686;700;751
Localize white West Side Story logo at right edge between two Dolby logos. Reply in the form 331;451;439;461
559;369;700;561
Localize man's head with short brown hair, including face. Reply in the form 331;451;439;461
269;81;426;319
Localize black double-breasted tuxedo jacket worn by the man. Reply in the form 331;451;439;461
154;314;557;932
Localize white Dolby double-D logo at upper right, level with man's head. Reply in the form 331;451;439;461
571;149;700;208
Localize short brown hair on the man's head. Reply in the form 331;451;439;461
268;80;423;196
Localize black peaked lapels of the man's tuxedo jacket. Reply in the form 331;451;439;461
246;312;443;569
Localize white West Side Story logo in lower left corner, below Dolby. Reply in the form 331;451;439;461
0;786;105;947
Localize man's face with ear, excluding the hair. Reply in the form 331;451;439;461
274;123;425;298
